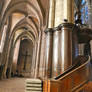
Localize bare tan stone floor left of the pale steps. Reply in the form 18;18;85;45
0;78;25;92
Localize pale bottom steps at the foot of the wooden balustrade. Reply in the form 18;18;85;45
25;79;42;92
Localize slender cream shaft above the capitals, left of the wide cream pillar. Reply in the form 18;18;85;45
48;0;55;28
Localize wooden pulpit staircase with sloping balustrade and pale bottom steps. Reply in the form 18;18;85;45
25;56;90;92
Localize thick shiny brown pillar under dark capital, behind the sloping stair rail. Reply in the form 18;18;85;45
52;23;72;78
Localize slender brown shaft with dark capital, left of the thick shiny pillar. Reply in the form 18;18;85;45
44;28;53;78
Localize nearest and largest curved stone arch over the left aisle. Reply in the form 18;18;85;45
1;0;42;33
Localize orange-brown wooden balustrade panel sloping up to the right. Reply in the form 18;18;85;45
43;56;89;92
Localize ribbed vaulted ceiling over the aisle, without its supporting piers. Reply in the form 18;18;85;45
0;0;49;46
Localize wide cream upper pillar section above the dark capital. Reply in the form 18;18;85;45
54;0;73;27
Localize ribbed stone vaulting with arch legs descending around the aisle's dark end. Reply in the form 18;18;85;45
0;0;48;78
